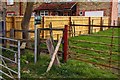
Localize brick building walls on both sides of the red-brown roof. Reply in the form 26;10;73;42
1;0;118;25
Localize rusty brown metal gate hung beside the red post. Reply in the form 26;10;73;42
69;24;120;73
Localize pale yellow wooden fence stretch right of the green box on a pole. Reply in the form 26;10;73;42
41;16;110;39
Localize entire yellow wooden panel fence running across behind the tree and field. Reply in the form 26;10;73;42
6;16;109;39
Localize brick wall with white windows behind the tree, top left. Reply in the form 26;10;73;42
2;2;40;16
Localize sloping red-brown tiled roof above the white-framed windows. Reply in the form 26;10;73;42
34;2;76;11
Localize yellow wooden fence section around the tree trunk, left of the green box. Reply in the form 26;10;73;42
6;16;37;39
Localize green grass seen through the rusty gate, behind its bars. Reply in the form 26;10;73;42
69;28;120;72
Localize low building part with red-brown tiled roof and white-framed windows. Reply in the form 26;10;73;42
34;2;76;16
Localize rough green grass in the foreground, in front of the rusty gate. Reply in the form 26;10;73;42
21;54;118;79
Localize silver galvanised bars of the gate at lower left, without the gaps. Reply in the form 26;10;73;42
0;37;20;79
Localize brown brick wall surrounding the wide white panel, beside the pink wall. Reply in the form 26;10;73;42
76;2;111;16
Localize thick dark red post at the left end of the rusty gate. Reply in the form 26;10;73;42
63;25;68;62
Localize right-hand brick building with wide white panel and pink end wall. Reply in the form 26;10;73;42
76;0;118;25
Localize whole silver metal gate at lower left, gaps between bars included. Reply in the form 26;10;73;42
0;37;20;80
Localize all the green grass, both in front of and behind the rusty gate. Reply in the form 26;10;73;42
1;29;119;80
